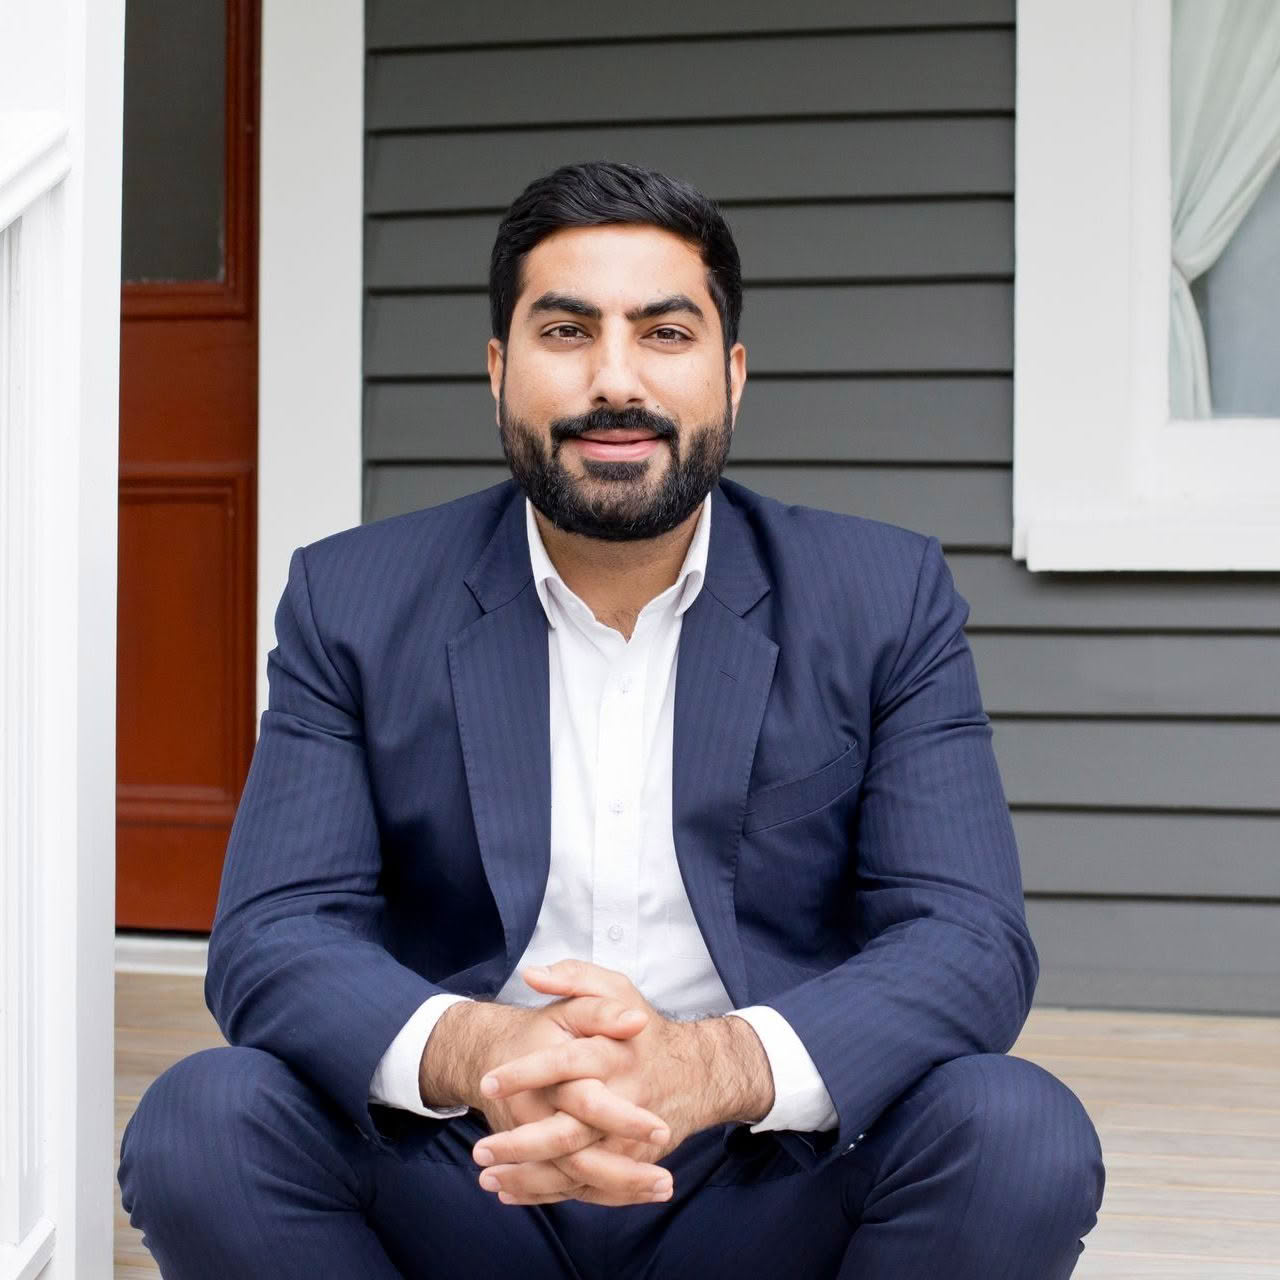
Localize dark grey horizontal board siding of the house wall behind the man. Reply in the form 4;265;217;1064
364;0;1280;1012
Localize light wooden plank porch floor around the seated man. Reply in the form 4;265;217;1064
115;974;1280;1280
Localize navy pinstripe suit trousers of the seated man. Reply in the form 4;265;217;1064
118;1047;1105;1280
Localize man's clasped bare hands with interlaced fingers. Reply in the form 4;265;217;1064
445;960;773;1206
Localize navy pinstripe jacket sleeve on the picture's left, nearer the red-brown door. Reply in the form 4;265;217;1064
205;549;442;1146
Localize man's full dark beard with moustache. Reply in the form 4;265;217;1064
498;376;733;543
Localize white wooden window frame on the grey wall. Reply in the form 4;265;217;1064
1014;0;1280;571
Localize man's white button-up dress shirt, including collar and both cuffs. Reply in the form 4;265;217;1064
369;494;837;1133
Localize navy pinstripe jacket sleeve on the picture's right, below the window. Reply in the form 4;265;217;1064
760;538;1039;1167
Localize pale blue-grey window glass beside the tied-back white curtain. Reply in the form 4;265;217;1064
1192;169;1280;417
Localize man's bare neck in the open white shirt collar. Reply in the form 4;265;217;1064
534;503;703;639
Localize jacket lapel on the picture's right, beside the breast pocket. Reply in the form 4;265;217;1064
672;485;778;1006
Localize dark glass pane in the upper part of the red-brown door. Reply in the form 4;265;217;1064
122;0;227;282
